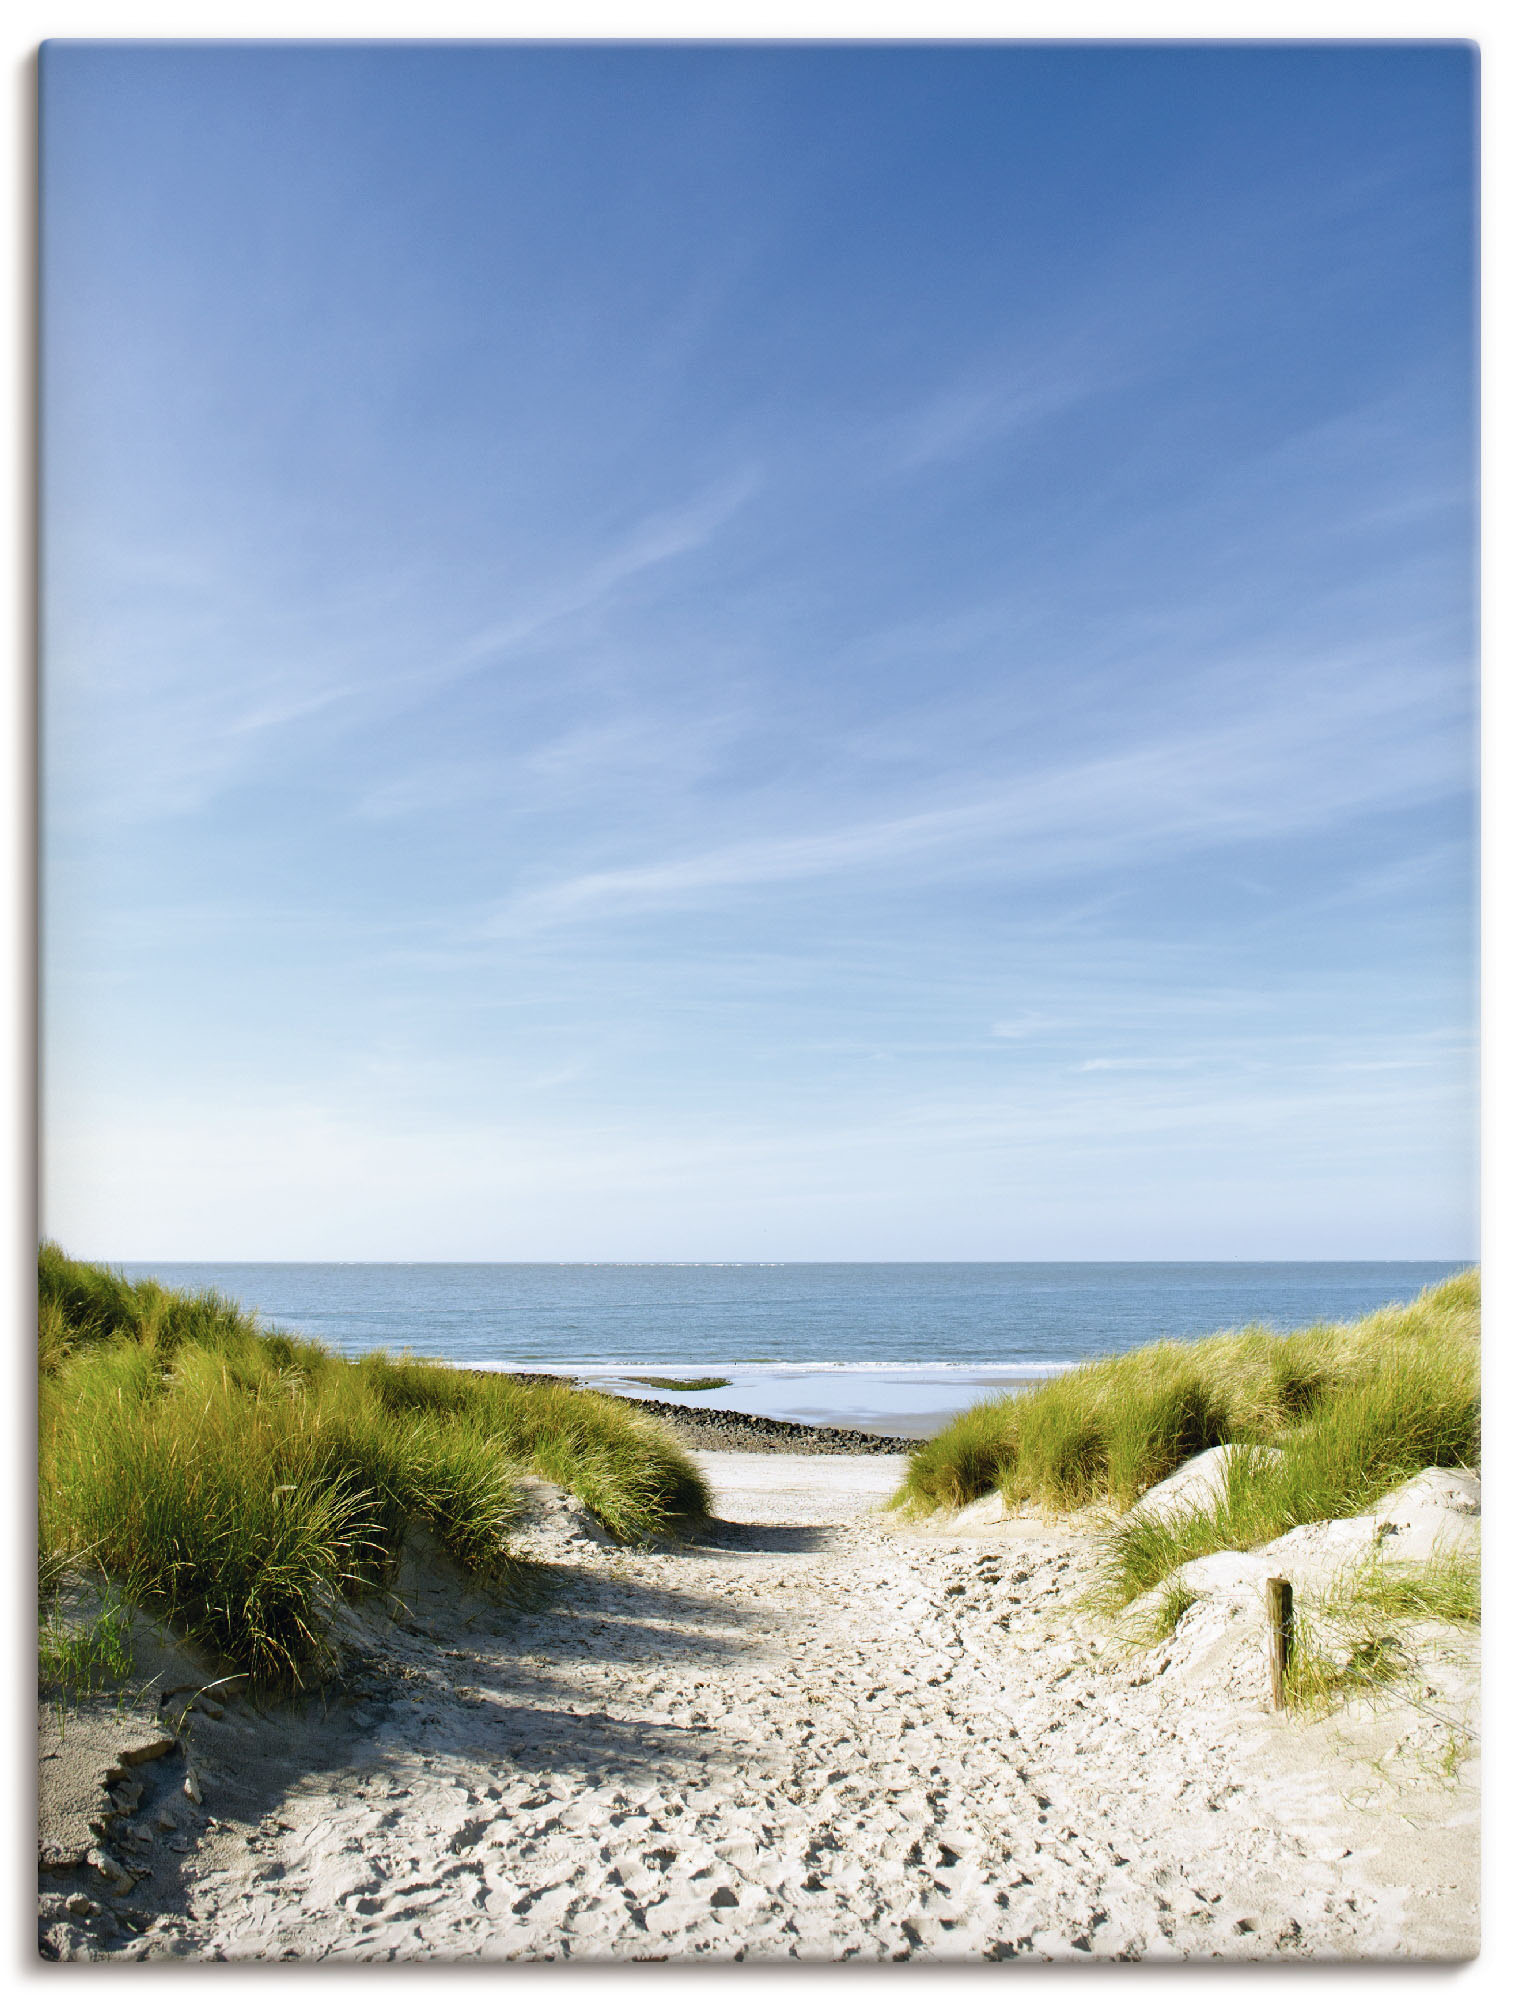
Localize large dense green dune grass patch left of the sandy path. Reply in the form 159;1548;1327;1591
38;1244;708;1684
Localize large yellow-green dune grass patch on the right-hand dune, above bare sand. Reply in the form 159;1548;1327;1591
895;1270;1481;1602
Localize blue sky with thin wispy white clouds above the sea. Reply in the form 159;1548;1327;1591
42;42;1477;1258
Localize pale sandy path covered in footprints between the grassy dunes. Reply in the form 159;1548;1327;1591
100;1454;1473;1960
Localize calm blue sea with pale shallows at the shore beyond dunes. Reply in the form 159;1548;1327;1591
112;1262;1465;1438
